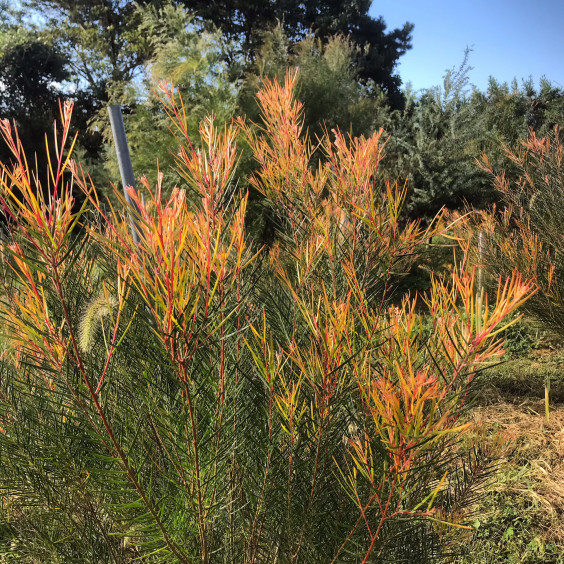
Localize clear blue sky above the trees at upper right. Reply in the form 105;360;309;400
370;0;564;90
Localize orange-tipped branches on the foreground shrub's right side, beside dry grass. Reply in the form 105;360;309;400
334;273;531;560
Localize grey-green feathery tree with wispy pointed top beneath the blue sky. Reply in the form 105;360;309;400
382;52;492;219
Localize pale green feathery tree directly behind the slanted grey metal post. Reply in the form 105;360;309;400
96;4;237;191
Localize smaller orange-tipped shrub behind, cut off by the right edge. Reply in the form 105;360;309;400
475;126;564;332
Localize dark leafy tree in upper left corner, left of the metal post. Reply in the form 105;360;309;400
0;0;156;191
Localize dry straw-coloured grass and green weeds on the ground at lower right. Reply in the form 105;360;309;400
460;394;564;564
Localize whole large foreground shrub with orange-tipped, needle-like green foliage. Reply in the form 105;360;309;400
0;74;530;563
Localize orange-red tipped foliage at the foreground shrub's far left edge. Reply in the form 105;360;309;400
0;102;81;378
